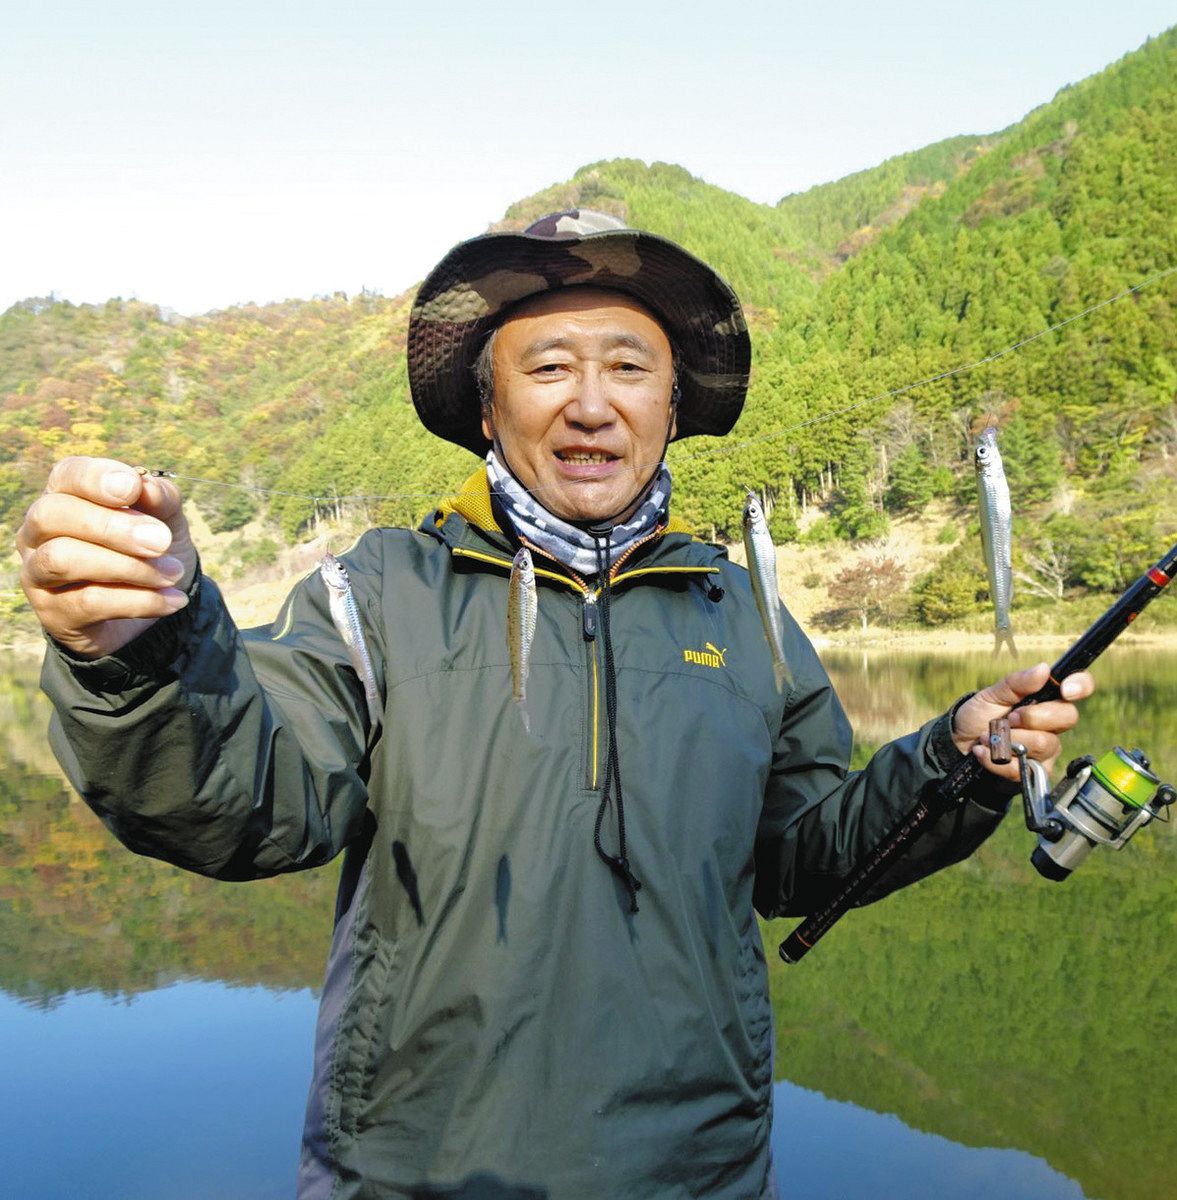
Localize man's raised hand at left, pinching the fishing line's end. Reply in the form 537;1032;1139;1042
17;457;197;659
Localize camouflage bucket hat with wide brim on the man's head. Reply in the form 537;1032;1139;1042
408;209;751;455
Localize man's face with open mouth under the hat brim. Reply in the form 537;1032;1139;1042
482;288;673;521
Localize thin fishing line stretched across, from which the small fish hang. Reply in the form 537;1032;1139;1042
114;265;1177;505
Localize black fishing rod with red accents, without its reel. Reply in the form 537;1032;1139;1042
780;545;1177;962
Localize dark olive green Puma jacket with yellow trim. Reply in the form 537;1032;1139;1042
44;473;999;1200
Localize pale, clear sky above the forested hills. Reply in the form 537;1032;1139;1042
0;0;1177;314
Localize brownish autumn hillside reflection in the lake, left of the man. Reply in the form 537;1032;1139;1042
0;660;335;1006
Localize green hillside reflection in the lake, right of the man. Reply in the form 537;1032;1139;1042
767;650;1177;1200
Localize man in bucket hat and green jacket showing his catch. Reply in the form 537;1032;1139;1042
19;211;1092;1200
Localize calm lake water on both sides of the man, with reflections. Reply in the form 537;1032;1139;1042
0;647;1177;1200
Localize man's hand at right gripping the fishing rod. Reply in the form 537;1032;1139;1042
953;662;1095;782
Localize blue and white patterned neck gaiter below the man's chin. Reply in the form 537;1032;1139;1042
486;450;671;576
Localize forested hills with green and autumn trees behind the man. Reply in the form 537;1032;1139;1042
0;29;1177;619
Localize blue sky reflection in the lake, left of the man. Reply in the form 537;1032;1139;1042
0;983;316;1200
